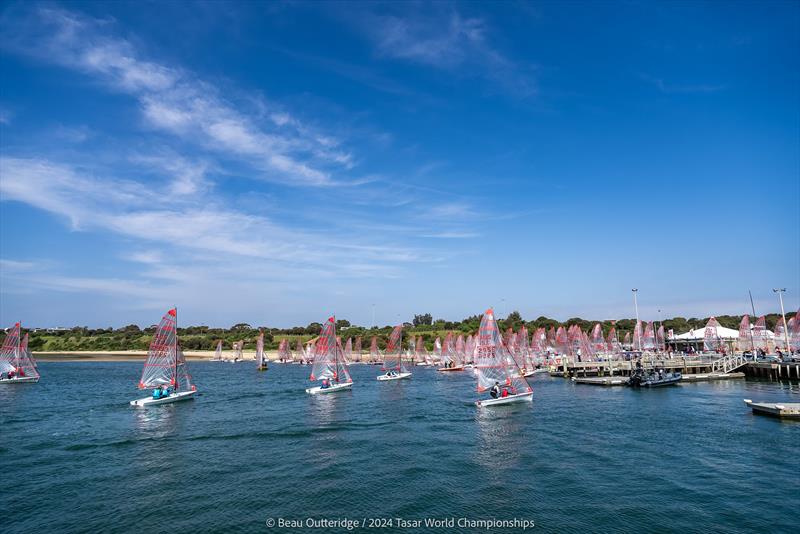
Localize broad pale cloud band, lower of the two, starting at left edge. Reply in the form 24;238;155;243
0;157;422;275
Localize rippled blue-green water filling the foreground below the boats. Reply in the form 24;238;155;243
0;362;800;533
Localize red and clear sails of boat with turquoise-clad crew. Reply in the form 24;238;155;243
139;308;195;391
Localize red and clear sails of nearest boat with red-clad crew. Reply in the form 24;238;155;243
475;308;533;395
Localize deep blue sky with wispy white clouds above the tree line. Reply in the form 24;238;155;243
0;2;800;326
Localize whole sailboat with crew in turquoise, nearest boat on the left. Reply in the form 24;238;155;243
131;308;197;407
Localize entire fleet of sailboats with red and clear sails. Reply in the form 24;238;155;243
0;308;800;407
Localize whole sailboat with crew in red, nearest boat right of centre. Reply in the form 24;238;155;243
475;308;533;407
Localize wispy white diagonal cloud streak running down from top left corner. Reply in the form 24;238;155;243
2;7;354;186
